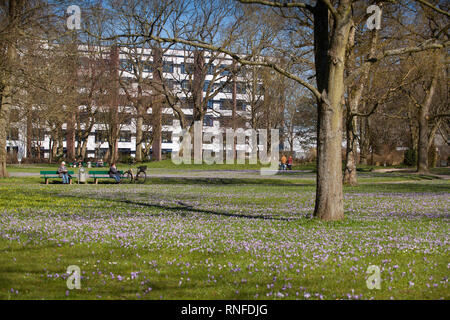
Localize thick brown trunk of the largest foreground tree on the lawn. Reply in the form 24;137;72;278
314;0;351;220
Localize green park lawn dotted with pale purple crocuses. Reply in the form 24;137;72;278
0;168;450;300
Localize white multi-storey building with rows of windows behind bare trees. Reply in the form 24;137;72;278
7;46;310;161
